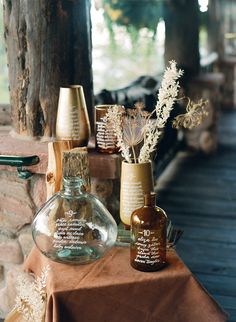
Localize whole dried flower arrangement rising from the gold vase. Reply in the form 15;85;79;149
103;61;207;163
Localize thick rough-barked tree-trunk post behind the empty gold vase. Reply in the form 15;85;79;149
3;0;93;137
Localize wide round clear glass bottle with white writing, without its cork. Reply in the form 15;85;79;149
32;177;117;264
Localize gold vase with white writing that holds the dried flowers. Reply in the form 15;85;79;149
120;161;154;226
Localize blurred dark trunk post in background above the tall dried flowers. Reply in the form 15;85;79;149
163;0;200;77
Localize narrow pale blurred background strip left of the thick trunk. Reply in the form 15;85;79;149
0;2;9;104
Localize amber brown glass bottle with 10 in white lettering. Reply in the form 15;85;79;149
130;192;167;272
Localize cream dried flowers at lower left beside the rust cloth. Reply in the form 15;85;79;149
13;265;50;322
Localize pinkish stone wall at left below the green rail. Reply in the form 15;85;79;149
0;170;46;317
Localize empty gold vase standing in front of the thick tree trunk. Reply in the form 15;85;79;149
56;85;91;146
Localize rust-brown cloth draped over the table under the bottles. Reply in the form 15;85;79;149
25;247;227;322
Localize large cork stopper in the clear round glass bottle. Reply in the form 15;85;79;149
62;147;90;191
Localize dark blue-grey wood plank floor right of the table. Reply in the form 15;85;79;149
157;111;236;322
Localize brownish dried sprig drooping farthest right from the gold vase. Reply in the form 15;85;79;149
172;97;208;130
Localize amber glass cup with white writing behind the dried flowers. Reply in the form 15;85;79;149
94;105;119;153
